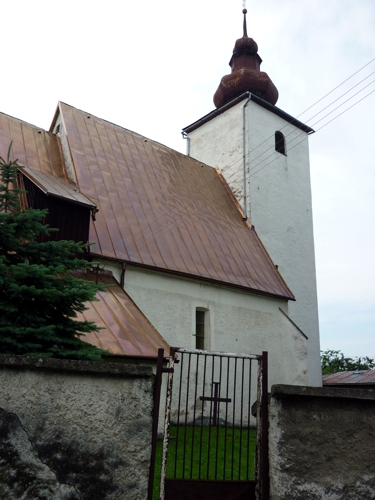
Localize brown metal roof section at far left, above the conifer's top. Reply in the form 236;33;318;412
0;113;65;179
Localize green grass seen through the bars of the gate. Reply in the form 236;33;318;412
153;425;256;500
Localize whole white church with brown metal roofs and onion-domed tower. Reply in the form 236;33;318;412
0;10;321;386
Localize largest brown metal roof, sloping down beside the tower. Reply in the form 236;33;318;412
60;99;294;299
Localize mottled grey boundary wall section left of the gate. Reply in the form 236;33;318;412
0;355;154;500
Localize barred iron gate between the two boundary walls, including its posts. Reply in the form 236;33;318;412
149;348;268;500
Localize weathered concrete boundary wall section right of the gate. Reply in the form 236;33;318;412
269;386;375;500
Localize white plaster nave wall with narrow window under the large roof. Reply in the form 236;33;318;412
125;266;307;386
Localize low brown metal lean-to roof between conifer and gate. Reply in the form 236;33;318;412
73;272;169;358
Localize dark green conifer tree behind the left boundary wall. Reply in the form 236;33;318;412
0;147;109;360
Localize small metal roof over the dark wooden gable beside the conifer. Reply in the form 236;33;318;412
18;166;96;208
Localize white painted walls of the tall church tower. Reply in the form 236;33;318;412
189;99;322;386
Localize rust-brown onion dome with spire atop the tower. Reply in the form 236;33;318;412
214;9;279;108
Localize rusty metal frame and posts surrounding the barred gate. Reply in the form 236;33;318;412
148;348;269;500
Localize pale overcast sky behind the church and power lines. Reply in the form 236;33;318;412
0;0;375;358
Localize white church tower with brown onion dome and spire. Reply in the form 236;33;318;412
183;9;322;386
